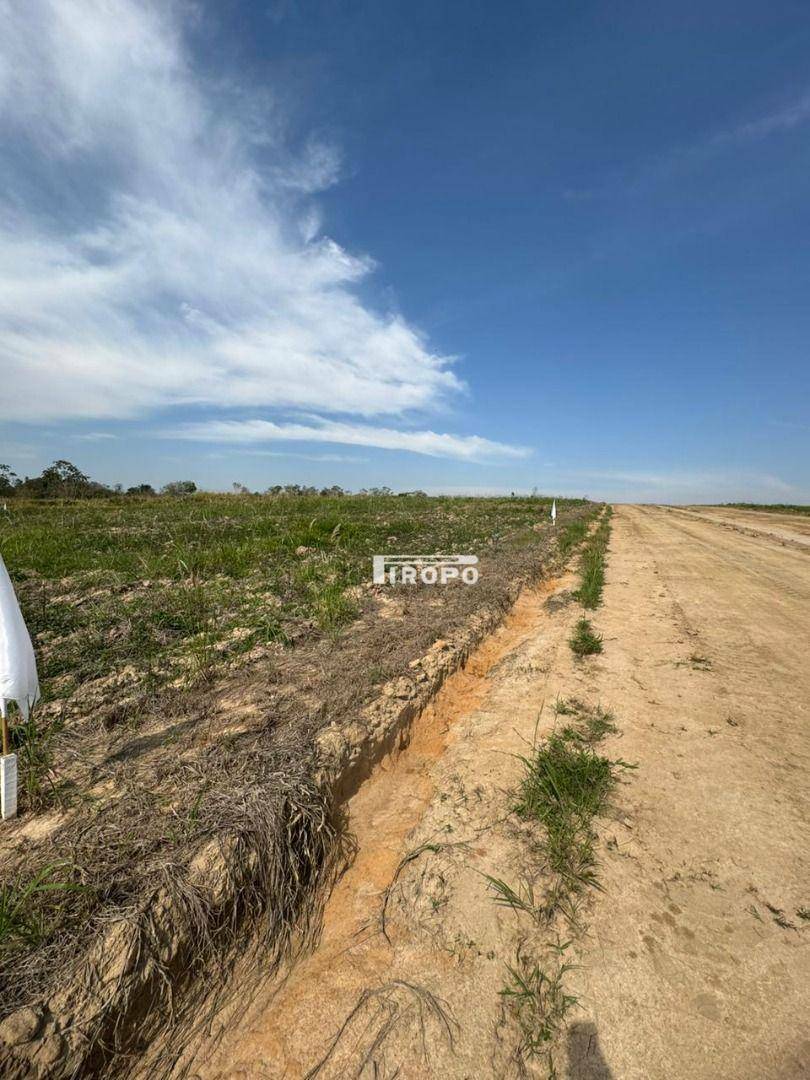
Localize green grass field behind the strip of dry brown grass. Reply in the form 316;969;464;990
0;495;587;730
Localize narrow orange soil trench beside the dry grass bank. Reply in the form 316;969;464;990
192;578;561;1080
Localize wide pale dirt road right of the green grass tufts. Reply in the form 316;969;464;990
573;508;810;1080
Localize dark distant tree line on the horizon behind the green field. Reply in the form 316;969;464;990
0;460;426;499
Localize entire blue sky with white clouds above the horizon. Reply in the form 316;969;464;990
0;0;810;501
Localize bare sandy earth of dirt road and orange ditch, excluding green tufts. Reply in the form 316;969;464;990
183;507;810;1080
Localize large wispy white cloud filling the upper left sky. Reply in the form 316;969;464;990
0;0;481;438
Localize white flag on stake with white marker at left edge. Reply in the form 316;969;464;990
0;555;39;821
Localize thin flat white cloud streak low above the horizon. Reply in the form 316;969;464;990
167;417;531;461
